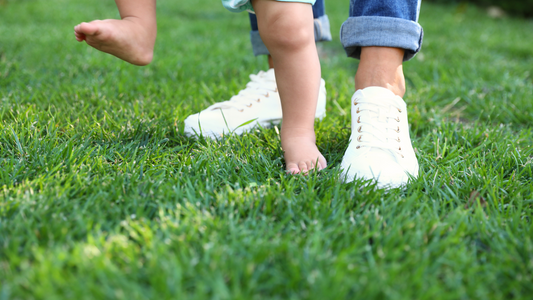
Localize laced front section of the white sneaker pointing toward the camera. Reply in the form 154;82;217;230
352;98;404;157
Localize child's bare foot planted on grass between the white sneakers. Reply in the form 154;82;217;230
281;128;328;174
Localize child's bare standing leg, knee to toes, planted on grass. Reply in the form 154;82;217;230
252;0;327;173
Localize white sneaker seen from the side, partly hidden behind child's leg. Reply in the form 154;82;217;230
185;69;326;138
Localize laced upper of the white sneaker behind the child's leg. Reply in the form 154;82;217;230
207;71;278;112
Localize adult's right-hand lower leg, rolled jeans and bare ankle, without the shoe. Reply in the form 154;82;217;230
341;0;423;97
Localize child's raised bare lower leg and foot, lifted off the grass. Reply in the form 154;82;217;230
74;0;157;66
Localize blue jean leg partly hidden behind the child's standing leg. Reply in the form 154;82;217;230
249;0;331;56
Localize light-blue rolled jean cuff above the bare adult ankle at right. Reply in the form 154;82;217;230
340;16;424;61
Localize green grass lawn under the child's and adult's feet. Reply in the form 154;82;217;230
0;0;533;300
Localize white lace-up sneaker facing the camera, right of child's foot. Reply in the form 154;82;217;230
341;87;418;188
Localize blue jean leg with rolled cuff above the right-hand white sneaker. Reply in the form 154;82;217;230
341;0;424;61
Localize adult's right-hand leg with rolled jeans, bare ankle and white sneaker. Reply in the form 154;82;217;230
341;0;423;187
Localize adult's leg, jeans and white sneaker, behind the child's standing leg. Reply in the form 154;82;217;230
184;0;331;138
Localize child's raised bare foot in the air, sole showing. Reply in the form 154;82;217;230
74;18;156;66
